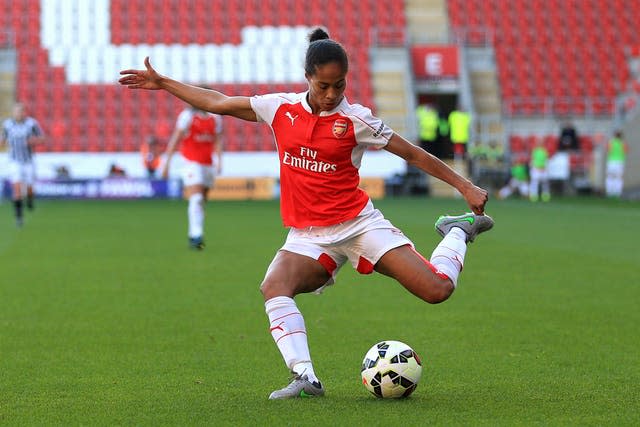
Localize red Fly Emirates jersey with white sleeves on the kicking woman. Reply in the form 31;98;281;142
251;92;393;228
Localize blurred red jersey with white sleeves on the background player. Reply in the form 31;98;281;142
176;108;222;165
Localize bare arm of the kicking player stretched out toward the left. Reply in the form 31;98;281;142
118;57;257;122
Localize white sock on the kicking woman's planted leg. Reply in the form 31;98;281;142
264;297;318;382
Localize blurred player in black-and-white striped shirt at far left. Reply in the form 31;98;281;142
0;103;44;227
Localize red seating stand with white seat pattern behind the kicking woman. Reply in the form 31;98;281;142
0;0;405;152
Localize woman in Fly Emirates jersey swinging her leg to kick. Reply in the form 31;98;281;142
120;28;493;399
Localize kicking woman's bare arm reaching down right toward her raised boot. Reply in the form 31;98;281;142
385;133;489;215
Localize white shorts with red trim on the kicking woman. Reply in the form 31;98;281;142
281;201;414;291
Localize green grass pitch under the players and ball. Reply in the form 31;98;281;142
0;199;640;426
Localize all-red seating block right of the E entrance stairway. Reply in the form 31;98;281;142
448;0;640;115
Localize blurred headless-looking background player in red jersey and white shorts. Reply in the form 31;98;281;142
162;107;223;250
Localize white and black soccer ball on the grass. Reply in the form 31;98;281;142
361;341;422;398
